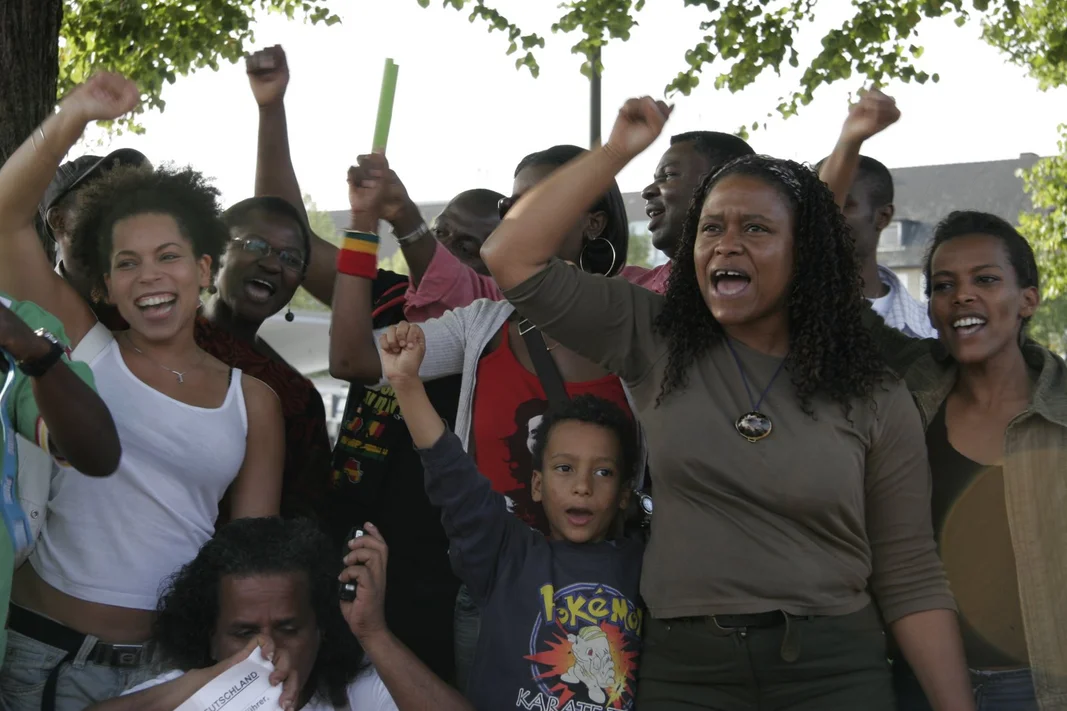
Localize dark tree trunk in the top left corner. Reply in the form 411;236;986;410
0;0;63;162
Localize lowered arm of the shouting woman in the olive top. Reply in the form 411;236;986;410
866;382;974;711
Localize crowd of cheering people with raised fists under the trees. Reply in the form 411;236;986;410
0;41;1067;711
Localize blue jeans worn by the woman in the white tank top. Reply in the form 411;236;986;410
0;630;156;711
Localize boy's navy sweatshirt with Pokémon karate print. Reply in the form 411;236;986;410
420;431;644;711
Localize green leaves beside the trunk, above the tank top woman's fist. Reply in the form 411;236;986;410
59;0;340;132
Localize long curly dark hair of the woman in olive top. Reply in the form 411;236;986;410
654;156;887;416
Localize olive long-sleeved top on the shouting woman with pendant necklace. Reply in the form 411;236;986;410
506;262;955;621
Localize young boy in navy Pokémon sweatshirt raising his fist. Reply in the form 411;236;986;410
380;323;643;711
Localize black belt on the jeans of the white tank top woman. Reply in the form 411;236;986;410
7;605;152;711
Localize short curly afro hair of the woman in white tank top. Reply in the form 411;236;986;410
70;165;229;299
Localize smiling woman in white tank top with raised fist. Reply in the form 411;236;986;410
0;74;285;711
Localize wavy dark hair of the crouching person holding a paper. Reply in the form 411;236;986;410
153;517;364;707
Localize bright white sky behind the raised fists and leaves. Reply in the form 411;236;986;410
73;0;1067;209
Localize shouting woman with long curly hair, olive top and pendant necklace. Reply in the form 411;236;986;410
482;98;974;711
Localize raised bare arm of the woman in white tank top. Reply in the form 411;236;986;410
0;73;140;346
